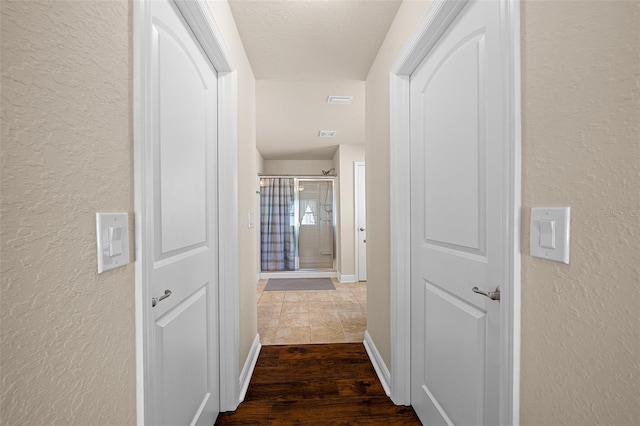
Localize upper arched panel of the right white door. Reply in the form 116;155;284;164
421;33;485;251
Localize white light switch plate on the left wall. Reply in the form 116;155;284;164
96;213;129;273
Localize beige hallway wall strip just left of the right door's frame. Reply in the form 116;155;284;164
365;0;430;366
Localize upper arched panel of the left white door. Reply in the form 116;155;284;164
154;21;210;254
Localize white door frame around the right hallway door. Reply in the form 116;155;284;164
390;0;522;425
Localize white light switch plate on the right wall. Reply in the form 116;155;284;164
529;207;571;264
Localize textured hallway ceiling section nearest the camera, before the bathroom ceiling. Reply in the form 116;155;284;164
229;0;401;80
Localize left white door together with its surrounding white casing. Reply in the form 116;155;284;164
134;0;239;424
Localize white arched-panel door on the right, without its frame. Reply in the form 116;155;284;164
410;0;508;426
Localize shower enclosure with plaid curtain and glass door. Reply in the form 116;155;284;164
260;176;335;272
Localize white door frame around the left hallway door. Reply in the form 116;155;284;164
133;0;240;425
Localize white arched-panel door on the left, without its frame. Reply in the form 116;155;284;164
142;0;220;425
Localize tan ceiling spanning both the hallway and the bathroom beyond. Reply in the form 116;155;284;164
229;0;401;159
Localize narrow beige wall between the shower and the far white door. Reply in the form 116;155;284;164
331;145;364;281
